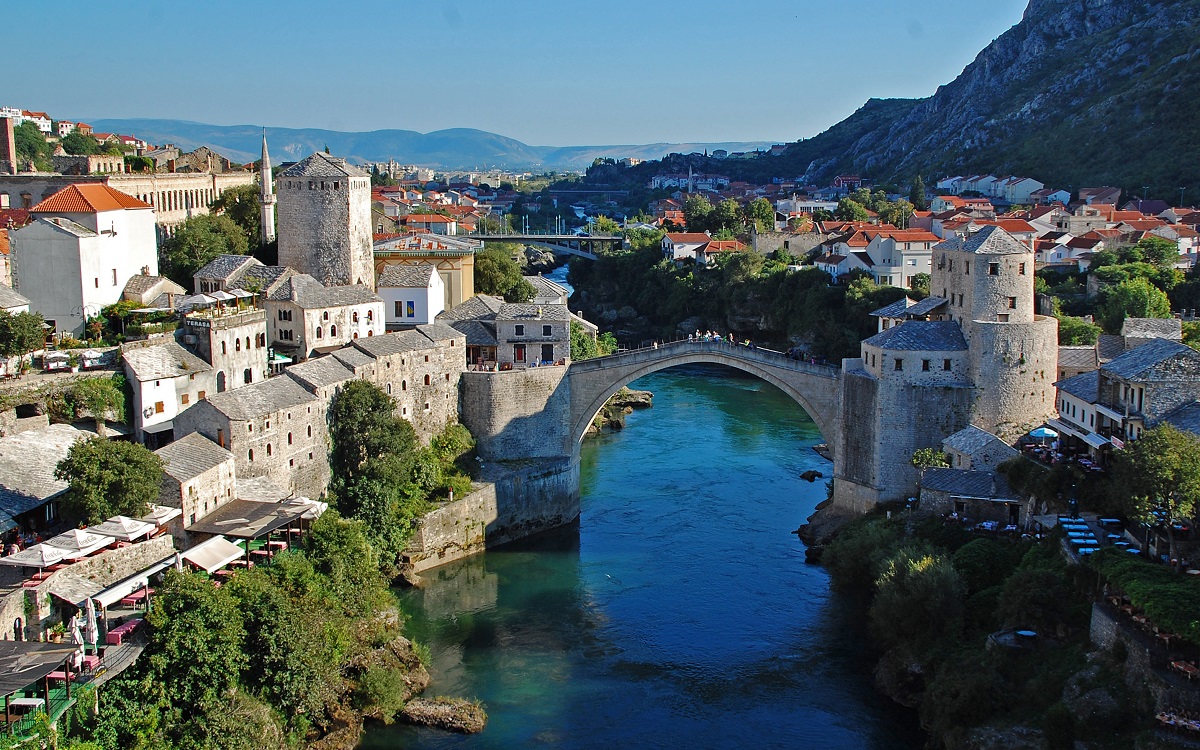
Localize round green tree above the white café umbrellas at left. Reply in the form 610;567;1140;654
54;437;162;523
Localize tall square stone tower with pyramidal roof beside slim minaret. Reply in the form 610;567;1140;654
275;154;374;289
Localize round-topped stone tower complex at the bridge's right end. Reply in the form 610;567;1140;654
834;227;1058;512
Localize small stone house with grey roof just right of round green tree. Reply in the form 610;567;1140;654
155;432;236;540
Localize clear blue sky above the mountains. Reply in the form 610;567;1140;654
0;0;1026;145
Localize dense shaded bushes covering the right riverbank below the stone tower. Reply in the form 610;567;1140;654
822;512;1090;744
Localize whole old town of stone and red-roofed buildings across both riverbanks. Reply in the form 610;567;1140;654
0;92;1200;736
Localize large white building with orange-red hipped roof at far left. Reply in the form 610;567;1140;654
11;184;158;334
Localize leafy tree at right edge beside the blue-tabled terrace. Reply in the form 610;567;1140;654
1116;422;1200;559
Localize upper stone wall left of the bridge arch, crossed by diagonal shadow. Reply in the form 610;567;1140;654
461;367;572;462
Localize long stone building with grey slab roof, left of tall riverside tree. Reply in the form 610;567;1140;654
175;377;329;497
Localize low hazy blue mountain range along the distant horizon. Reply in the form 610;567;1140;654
89;119;770;169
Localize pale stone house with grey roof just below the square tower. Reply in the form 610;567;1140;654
266;274;386;360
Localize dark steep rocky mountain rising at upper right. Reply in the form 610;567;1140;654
676;0;1200;203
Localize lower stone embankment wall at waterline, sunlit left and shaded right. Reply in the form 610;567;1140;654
403;458;580;574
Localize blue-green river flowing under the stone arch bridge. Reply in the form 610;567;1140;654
362;366;922;750
